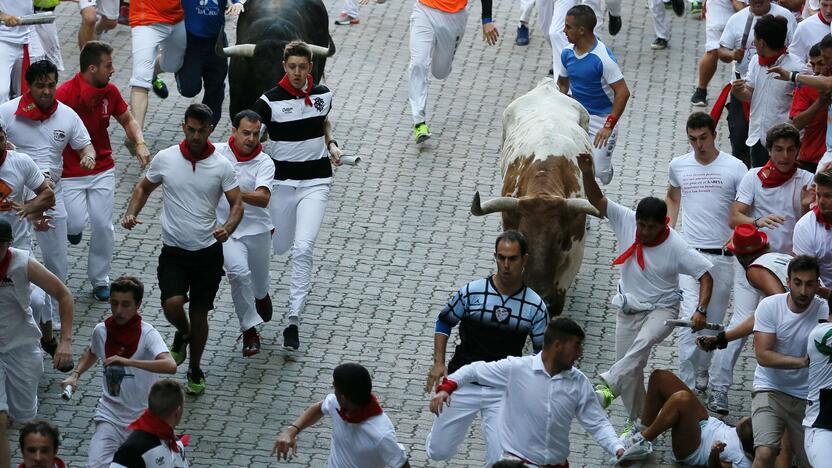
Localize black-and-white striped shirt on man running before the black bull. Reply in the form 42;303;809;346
252;85;332;187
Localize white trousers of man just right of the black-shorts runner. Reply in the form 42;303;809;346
222;231;272;331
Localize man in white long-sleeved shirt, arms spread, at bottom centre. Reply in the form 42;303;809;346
430;316;624;466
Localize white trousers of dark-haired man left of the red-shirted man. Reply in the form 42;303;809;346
35;181;68;331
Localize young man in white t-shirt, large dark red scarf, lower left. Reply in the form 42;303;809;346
61;276;176;468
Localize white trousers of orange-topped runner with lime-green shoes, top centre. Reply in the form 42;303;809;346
408;1;468;124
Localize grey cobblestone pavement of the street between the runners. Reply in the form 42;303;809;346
10;0;753;467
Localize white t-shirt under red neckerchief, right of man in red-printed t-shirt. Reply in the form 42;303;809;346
736;167;814;255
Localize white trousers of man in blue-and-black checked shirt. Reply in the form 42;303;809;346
425;384;503;466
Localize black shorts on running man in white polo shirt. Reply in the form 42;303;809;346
156;242;225;310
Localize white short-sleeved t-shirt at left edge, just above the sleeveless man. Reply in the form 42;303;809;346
0;151;46;250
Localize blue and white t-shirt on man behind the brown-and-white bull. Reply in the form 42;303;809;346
560;40;624;116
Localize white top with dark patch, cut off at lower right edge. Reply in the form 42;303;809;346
803;322;832;430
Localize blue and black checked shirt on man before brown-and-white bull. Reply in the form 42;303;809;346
436;277;547;372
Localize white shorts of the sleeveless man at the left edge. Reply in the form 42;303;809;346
0;341;43;422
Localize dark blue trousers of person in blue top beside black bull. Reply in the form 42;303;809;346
176;33;228;126
